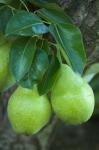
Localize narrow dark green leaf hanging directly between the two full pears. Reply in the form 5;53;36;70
38;56;60;94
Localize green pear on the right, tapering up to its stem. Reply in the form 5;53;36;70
51;64;95;125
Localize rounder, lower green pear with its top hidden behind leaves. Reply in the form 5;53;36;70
7;87;51;135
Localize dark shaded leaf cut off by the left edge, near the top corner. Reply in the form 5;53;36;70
0;6;13;33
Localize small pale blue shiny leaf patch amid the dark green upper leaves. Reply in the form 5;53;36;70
32;23;49;35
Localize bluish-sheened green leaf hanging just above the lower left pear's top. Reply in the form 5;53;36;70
21;49;49;88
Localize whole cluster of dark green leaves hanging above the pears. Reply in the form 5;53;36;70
0;0;86;94
